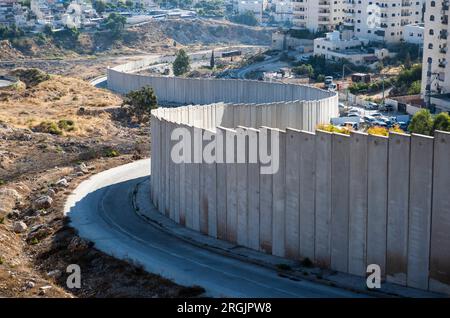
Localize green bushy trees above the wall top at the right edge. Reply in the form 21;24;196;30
408;109;450;136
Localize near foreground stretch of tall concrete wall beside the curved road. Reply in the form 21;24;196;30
151;105;450;293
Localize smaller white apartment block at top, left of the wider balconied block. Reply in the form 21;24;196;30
292;0;348;32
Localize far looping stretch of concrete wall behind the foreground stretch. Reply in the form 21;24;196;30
108;67;339;131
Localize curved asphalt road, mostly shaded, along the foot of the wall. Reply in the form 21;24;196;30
65;160;361;298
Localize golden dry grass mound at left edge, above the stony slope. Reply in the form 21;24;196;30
0;75;121;137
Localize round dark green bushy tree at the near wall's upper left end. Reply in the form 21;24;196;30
122;86;158;122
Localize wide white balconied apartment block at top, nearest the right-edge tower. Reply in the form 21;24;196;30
352;0;425;43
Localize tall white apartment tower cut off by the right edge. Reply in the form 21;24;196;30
422;0;450;111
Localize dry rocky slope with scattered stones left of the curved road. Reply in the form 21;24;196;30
0;70;202;297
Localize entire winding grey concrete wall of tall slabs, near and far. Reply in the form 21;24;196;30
108;54;450;294
